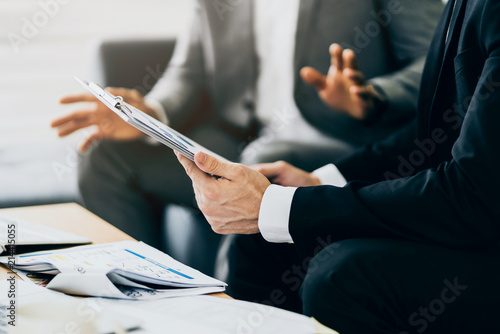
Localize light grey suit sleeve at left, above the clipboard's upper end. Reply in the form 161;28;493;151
147;0;206;127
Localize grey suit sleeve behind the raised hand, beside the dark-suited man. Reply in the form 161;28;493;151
369;0;443;124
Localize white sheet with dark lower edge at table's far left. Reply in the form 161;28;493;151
0;215;90;254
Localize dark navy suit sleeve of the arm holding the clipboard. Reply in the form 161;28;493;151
290;2;500;256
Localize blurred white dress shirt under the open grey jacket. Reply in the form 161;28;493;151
250;0;344;150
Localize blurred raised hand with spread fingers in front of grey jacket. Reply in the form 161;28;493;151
300;44;380;120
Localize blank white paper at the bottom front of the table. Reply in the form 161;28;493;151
94;296;322;334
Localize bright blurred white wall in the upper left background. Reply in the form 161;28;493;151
0;0;190;148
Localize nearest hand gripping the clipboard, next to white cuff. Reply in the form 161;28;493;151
176;152;271;234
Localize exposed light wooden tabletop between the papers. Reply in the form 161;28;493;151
0;203;231;298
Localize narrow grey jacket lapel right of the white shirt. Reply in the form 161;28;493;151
293;0;321;87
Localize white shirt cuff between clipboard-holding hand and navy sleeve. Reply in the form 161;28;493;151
259;184;297;244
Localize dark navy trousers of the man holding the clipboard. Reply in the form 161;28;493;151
228;235;500;334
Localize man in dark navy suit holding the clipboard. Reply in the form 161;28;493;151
178;0;500;333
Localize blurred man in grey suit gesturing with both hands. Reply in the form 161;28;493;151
52;0;442;246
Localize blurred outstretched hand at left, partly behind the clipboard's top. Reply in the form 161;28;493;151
51;88;154;152
